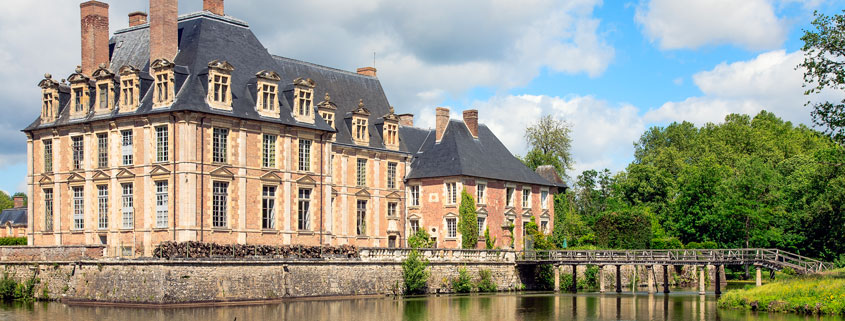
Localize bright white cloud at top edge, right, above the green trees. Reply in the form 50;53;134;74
635;0;787;50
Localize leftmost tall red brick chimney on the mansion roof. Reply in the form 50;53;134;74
79;0;109;76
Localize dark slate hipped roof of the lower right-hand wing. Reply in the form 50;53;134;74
399;120;557;186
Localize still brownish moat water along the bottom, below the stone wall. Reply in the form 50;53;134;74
0;292;845;321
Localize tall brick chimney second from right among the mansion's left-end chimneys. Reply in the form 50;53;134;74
150;0;179;63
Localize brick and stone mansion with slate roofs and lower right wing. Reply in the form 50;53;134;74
24;0;565;255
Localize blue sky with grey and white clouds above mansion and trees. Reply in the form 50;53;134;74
0;0;845;194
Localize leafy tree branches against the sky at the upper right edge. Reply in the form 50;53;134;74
798;11;845;144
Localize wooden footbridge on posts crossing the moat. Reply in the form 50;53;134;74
515;249;832;294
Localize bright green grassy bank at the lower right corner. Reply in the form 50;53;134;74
719;269;845;315
